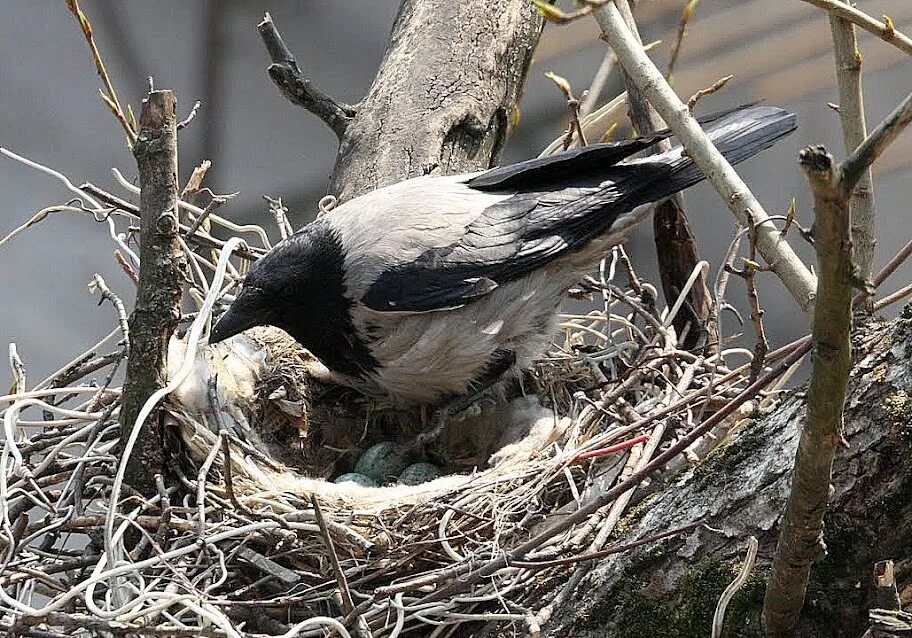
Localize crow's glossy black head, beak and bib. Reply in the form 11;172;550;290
209;220;376;375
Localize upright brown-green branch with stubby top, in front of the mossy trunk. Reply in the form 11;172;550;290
763;146;853;636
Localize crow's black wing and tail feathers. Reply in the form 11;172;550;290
362;106;796;312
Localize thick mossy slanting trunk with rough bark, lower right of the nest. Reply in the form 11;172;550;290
529;318;912;638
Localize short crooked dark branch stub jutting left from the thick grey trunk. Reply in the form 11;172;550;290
257;13;355;139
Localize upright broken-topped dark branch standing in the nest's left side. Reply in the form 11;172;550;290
120;91;185;494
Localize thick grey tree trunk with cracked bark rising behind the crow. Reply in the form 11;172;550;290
329;0;542;201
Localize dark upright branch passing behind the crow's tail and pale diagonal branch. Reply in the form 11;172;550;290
616;0;715;350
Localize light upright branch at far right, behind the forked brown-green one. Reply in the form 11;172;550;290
830;13;876;305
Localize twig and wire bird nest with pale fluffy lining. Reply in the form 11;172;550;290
0;161;800;637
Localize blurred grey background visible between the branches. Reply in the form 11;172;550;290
0;0;912;387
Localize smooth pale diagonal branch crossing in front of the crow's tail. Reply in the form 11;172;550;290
595;3;817;317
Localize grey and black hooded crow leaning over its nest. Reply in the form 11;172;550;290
209;106;796;405
